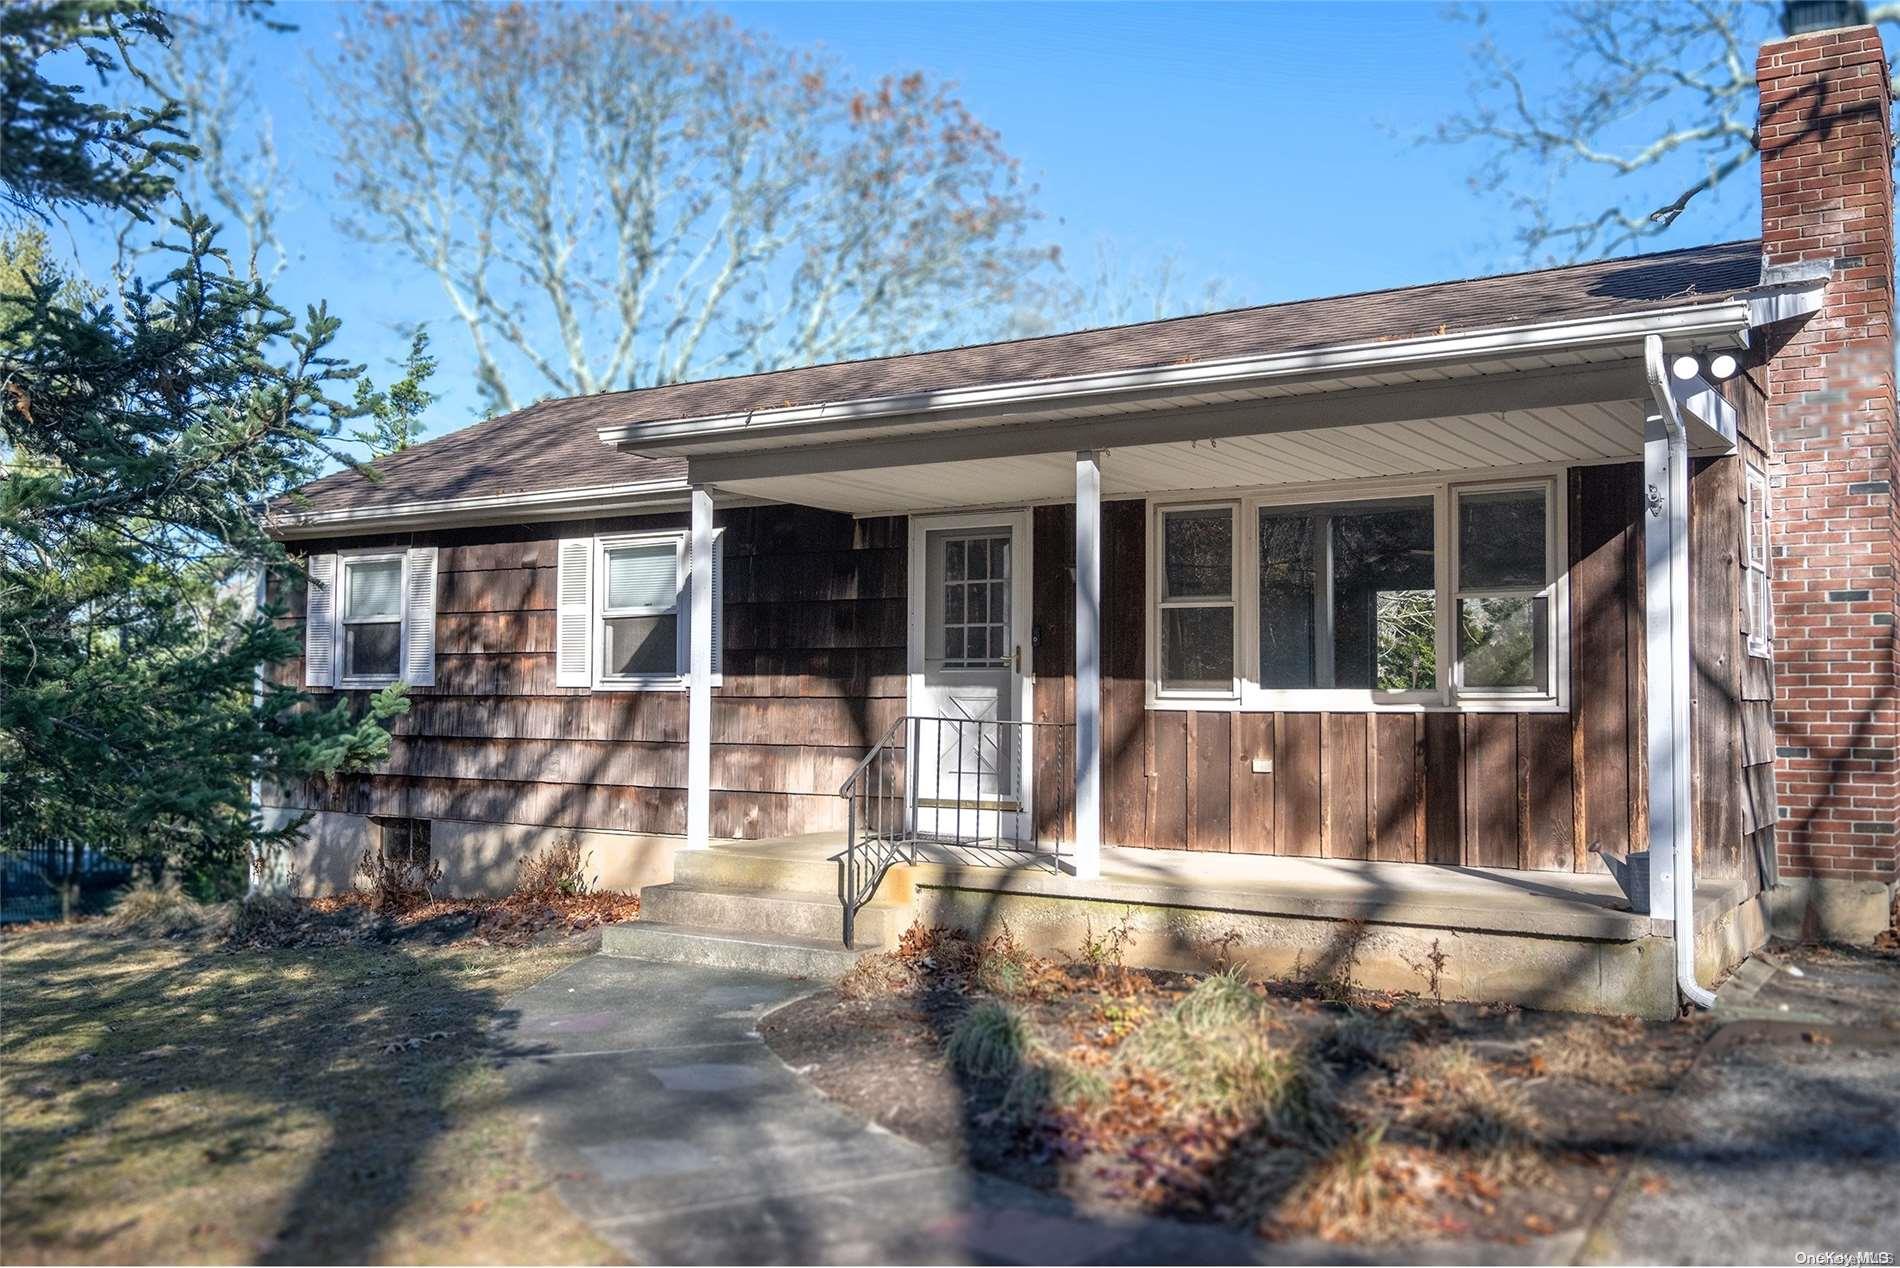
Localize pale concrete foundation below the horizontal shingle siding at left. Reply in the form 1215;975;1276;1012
264;808;684;897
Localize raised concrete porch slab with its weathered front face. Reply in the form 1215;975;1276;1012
699;833;1765;1017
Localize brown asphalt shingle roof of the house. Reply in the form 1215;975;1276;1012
283;241;1761;511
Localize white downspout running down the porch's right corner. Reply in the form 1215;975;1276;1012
1644;335;1716;1008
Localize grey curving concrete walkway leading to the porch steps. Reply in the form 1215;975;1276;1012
494;956;1575;1264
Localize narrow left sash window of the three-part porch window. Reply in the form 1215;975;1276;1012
1159;506;1235;696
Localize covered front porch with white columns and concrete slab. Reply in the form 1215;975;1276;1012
600;285;1759;1015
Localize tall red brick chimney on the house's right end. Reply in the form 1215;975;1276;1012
1756;17;1900;935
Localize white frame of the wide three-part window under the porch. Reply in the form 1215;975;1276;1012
1146;468;1569;713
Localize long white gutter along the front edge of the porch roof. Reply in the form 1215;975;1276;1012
599;298;1750;456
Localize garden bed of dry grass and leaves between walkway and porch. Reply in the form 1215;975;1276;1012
762;930;1708;1241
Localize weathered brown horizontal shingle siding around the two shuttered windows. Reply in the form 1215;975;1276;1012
276;506;906;838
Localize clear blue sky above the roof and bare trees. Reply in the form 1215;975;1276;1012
63;2;1752;450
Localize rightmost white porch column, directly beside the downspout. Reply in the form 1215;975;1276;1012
1644;413;1693;920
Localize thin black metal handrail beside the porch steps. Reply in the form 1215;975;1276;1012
838;713;1074;947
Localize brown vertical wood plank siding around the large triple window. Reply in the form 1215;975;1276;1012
1036;460;1765;876
